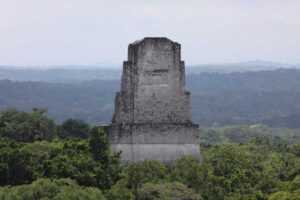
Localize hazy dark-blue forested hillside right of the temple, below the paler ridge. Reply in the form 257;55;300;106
187;69;300;128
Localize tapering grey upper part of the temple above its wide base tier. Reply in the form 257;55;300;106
113;38;191;123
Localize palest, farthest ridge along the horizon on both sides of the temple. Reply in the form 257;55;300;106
0;60;300;83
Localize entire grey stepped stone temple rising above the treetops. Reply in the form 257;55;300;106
109;38;200;162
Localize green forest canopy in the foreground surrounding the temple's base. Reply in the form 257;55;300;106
0;109;300;200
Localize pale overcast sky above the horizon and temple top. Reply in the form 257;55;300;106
0;0;300;65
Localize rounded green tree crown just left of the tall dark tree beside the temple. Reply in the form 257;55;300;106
41;140;99;187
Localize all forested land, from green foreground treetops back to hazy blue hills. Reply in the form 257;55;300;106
0;69;300;200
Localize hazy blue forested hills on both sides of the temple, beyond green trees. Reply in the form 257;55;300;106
0;69;300;128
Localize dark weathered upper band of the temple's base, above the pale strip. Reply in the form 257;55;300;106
108;123;199;144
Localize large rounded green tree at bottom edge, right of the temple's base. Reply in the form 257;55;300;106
195;144;273;200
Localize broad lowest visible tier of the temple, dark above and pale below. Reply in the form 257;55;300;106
109;123;200;162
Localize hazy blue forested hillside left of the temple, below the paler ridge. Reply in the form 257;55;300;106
0;80;119;123
